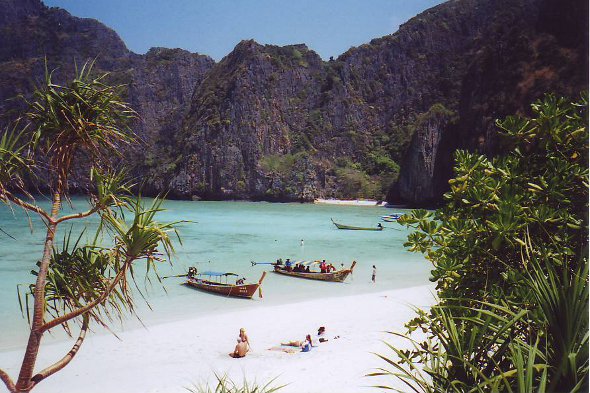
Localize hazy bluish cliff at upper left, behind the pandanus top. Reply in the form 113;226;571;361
0;0;214;188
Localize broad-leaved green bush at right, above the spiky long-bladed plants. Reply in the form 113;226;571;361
400;92;588;299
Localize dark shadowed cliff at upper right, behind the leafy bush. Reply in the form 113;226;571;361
388;0;588;206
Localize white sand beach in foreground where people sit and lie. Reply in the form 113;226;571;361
0;285;434;393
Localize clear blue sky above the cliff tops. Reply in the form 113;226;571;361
44;0;443;60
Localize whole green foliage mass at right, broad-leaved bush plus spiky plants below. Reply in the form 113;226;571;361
374;94;589;392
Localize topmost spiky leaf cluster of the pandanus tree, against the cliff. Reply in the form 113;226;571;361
23;62;135;192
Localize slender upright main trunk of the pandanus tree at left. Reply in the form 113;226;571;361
16;192;61;392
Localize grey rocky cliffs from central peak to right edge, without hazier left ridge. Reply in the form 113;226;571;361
156;0;588;205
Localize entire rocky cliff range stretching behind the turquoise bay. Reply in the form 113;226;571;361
0;0;588;205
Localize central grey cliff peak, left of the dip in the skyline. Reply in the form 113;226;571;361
157;41;330;199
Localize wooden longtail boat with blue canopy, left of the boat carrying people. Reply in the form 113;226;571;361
184;268;266;299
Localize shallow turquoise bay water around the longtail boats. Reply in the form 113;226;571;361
0;198;429;350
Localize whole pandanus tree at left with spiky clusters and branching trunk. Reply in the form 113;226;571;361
0;63;176;392
